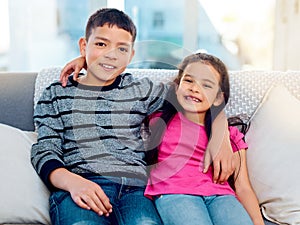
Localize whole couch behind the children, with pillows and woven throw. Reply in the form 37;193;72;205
0;67;300;225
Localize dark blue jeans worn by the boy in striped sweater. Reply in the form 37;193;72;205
50;176;162;225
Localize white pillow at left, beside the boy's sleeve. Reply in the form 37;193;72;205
0;124;50;224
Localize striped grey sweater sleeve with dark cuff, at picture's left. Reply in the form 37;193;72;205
31;85;64;189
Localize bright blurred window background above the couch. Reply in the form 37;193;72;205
0;0;300;72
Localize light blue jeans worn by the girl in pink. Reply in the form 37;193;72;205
155;194;253;225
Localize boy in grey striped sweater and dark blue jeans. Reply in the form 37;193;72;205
31;9;232;225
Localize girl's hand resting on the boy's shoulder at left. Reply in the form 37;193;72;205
60;56;86;87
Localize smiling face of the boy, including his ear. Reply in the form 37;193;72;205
79;25;134;86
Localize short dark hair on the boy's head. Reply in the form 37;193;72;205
85;8;136;43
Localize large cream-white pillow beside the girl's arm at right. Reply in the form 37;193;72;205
246;86;300;224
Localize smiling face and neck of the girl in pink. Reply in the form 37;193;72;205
176;62;223;124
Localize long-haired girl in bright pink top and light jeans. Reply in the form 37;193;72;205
145;53;264;225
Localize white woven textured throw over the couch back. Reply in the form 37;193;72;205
34;67;300;122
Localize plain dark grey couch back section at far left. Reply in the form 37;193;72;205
0;73;37;131
